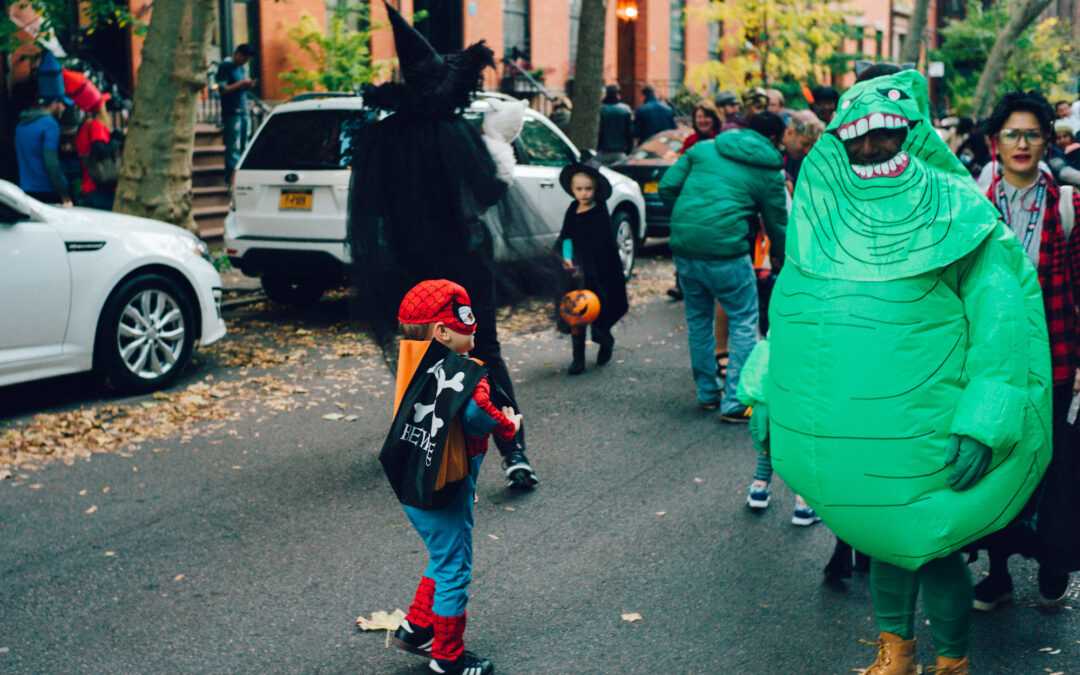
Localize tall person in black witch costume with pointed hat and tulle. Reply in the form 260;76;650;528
349;4;537;489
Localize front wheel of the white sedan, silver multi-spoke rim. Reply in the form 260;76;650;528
94;274;198;392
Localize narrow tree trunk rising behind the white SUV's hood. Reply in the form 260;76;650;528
567;0;607;149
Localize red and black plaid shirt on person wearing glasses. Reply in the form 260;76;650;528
986;173;1080;387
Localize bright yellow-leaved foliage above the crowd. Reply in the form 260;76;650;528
687;0;862;91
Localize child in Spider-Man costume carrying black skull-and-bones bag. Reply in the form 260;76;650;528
380;279;522;675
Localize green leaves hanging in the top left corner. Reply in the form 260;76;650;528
0;0;147;54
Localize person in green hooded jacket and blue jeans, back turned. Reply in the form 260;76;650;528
659;112;787;422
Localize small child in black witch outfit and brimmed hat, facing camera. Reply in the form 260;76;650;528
555;164;629;375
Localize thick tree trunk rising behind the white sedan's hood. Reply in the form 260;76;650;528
113;0;217;231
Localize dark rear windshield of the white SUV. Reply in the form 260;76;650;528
240;110;373;171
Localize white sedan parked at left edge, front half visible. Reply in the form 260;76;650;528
0;180;226;391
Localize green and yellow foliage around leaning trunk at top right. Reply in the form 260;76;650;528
931;0;1078;114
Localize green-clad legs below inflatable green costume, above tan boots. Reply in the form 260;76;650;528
870;553;971;658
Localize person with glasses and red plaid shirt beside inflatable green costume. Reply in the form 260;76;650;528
973;91;1080;611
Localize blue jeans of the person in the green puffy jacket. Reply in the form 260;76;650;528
675;256;758;413
